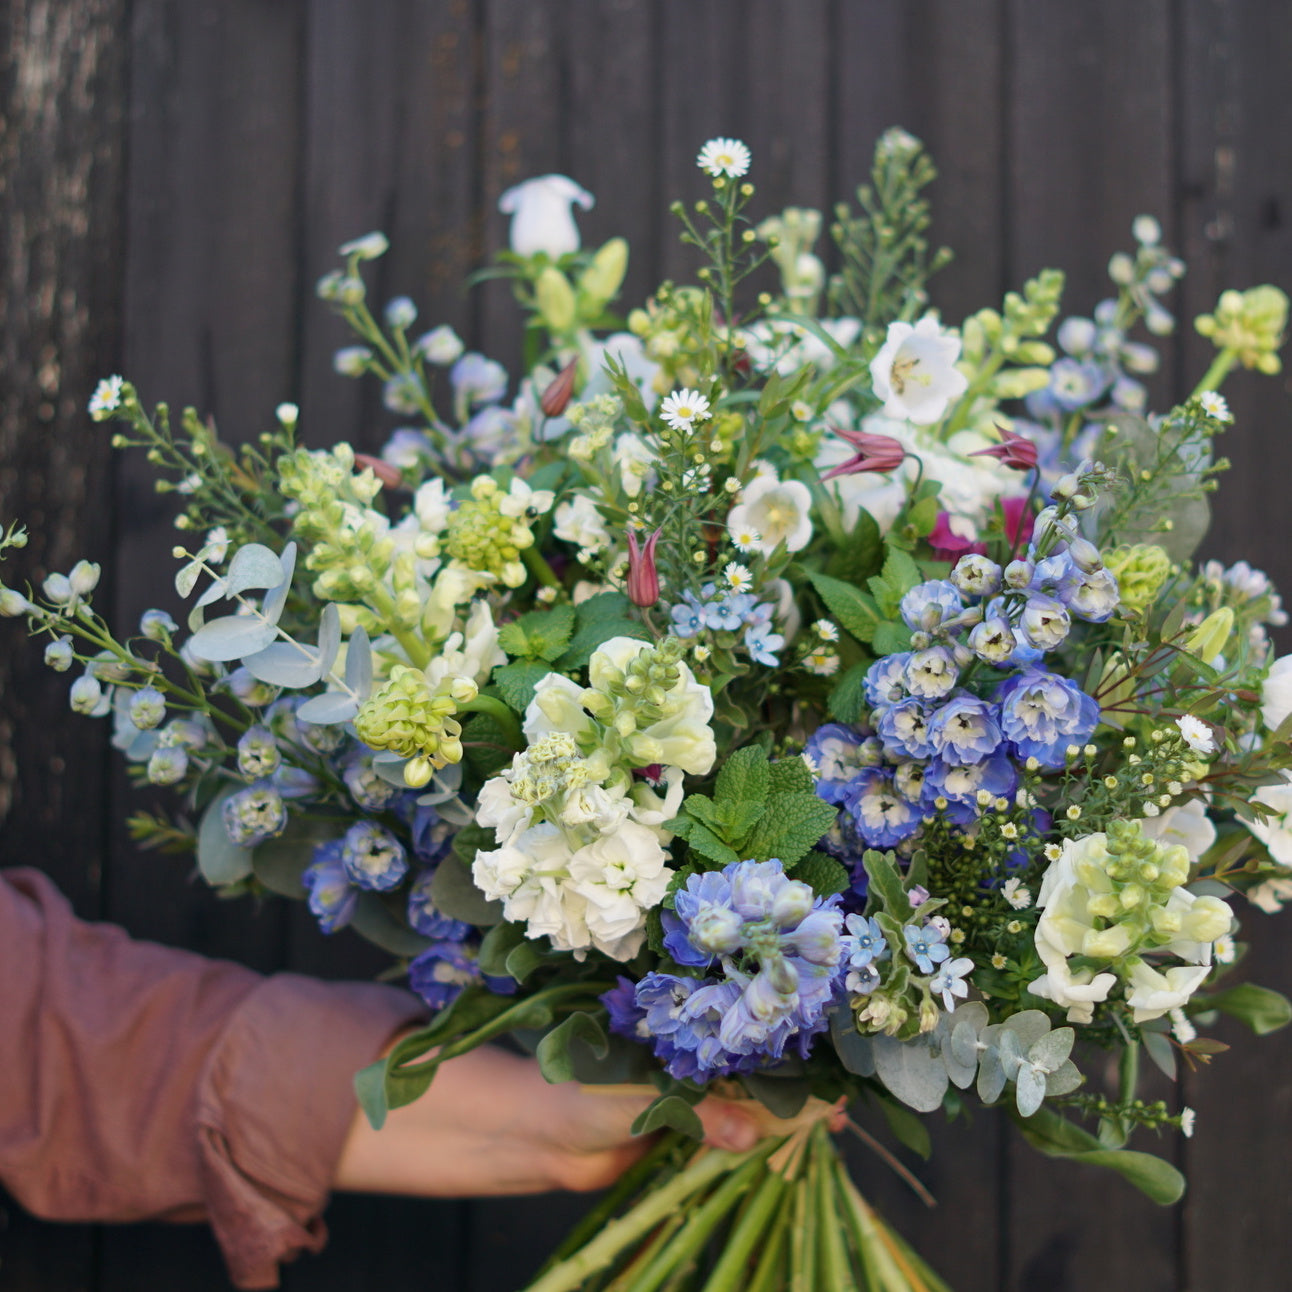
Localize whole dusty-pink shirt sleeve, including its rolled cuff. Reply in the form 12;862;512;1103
0;870;422;1288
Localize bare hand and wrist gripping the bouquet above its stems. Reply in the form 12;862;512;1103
333;1047;766;1198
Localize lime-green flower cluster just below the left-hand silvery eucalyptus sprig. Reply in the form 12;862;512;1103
354;664;477;789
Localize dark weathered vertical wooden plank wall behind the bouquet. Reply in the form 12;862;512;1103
0;0;1292;1292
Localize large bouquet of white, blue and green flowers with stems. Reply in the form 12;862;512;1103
0;130;1292;1292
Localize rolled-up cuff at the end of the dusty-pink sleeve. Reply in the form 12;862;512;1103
196;974;425;1288
